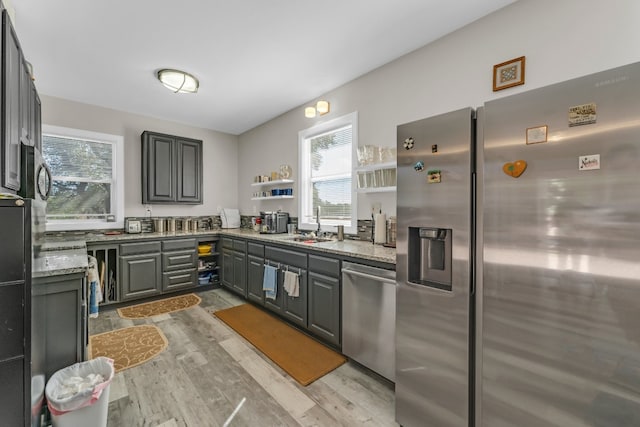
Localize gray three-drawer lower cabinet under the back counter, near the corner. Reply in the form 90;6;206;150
162;239;198;292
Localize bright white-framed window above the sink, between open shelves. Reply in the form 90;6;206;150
298;112;358;234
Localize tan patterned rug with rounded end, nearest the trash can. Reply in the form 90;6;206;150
89;325;168;372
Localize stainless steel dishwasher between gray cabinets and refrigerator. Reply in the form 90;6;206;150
342;262;396;381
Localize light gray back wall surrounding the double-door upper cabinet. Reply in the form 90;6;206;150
41;96;238;216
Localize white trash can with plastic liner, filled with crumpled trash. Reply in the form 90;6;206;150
45;357;114;427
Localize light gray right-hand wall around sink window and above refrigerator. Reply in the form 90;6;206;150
238;0;640;219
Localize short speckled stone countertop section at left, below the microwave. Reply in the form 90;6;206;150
32;239;88;279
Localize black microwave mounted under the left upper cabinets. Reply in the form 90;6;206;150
18;144;52;200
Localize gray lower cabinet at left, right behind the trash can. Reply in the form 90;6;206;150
31;272;88;380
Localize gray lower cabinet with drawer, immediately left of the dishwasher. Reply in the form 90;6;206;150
308;255;342;347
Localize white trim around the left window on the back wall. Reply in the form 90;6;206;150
42;124;124;231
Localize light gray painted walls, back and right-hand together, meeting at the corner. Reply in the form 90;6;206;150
42;0;640;219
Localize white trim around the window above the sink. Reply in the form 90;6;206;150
298;111;358;234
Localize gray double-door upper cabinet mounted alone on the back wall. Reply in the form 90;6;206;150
142;131;202;204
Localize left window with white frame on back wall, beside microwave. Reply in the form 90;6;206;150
42;125;124;230
